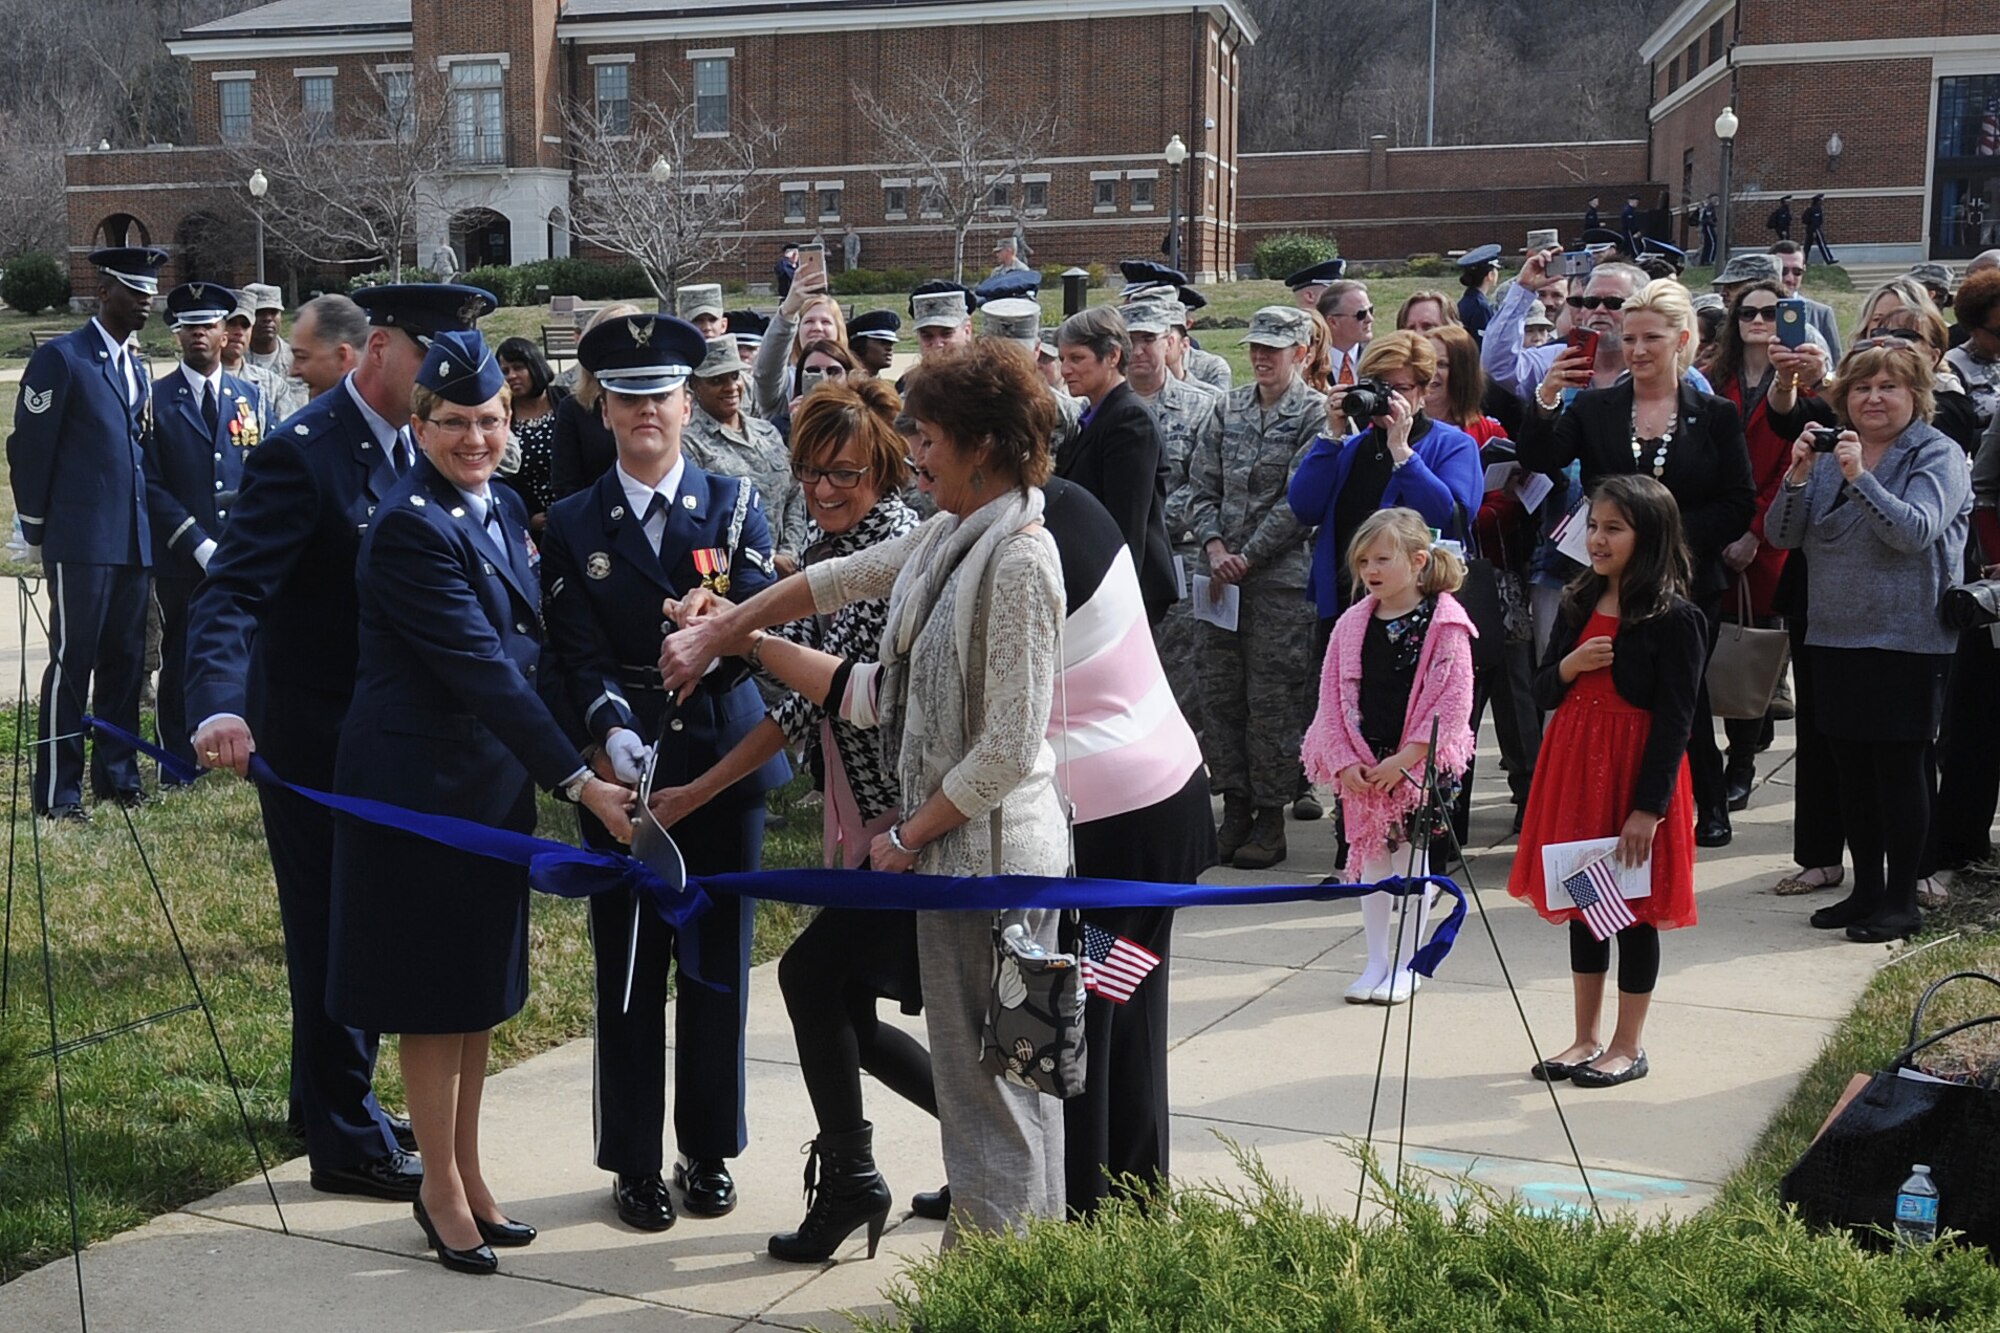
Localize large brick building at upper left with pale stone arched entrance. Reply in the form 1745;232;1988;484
68;0;1256;290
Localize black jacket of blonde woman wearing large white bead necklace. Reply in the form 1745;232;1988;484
1516;380;1756;602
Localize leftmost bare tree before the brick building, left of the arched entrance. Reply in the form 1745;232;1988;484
226;70;468;282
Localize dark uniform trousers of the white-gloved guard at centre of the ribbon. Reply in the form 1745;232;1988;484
578;801;764;1175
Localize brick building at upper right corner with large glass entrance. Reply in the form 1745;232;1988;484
1640;0;2000;262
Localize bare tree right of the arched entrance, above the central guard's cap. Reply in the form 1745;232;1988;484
562;90;782;306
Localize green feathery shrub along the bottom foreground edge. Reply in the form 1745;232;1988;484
864;1136;2000;1333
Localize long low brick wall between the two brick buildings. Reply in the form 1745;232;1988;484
1236;142;1662;264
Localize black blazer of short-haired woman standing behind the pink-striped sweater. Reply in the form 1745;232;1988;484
1056;382;1176;624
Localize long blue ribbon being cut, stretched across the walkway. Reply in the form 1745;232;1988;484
84;715;1466;976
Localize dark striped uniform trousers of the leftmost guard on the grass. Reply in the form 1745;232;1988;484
30;560;152;815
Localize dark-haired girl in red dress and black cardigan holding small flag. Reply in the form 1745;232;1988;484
1508;474;1708;1087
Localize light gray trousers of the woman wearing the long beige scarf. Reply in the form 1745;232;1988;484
916;911;1064;1249
